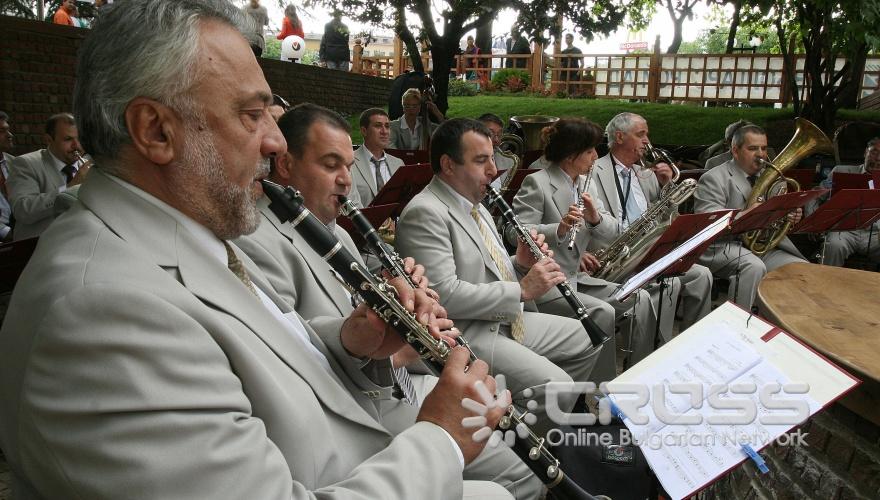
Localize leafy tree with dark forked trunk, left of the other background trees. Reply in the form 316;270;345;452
310;0;650;112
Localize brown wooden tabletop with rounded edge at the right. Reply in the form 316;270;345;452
757;263;880;425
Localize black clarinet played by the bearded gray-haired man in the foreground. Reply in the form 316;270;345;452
261;180;594;500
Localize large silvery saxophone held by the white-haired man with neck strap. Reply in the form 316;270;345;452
592;160;697;283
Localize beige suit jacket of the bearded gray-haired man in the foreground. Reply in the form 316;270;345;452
0;171;462;500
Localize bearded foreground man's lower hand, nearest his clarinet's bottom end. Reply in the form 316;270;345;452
416;347;511;464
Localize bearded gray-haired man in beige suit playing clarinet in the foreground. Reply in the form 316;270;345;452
0;0;509;500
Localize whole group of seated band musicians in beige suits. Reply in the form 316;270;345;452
0;0;880;499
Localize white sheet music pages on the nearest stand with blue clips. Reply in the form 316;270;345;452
608;321;822;500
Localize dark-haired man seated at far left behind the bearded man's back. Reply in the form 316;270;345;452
6;113;89;240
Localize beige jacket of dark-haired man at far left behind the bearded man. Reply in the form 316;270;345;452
6;149;67;240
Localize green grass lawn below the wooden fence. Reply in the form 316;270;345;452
351;96;880;145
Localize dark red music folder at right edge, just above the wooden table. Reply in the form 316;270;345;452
792;189;880;233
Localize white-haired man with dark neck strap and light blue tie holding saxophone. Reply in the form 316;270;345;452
590;113;712;341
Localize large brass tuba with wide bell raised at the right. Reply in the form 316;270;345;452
742;118;834;256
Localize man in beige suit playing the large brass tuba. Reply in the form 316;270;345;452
694;125;806;309
